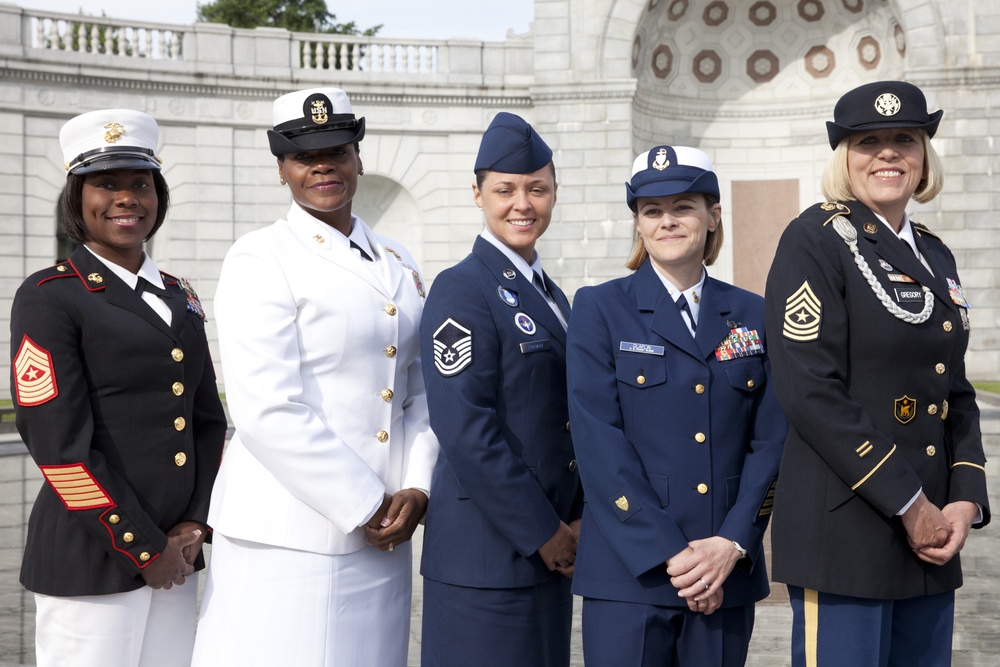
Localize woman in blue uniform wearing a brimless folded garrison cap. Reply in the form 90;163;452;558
420;113;581;667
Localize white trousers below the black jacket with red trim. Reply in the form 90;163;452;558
35;573;198;667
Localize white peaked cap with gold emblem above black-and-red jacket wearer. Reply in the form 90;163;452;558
59;109;160;174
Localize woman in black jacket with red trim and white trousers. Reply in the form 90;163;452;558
11;109;226;667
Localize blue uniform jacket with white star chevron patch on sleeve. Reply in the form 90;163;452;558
420;238;581;588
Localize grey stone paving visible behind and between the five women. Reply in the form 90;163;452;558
0;396;1000;667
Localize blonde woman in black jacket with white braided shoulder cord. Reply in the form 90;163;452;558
767;81;990;667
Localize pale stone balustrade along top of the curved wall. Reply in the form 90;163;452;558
0;4;534;86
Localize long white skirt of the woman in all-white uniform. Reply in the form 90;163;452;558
192;531;413;667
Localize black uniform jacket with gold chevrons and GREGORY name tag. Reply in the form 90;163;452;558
767;201;990;600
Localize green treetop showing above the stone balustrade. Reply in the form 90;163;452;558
198;0;382;36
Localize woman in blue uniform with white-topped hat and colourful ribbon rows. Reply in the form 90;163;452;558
567;146;787;667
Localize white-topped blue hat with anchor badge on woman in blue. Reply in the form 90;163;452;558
625;146;721;211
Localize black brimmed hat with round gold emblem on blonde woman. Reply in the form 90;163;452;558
826;81;944;149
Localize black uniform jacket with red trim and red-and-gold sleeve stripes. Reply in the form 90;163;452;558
10;247;226;596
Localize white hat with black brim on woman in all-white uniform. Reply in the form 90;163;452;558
267;88;365;157
